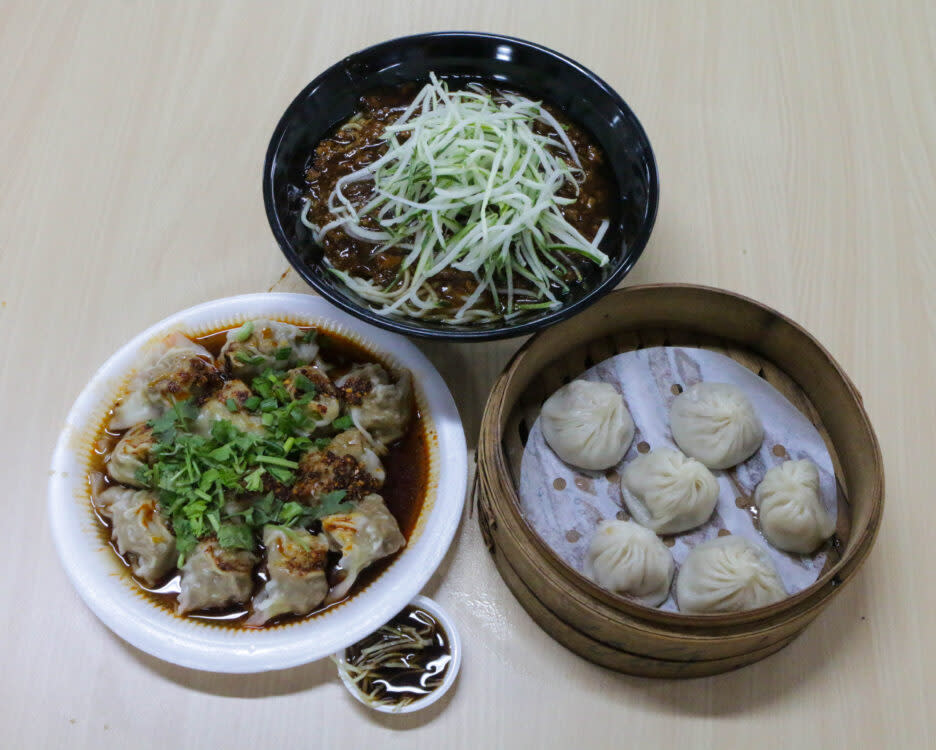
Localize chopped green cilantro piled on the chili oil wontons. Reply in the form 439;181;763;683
137;364;370;566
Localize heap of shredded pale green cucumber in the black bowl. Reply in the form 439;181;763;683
302;74;608;324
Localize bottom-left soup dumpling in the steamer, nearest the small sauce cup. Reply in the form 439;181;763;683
585;520;676;607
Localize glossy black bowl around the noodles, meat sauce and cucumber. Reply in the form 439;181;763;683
263;31;659;341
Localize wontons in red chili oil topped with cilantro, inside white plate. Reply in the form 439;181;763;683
89;319;427;627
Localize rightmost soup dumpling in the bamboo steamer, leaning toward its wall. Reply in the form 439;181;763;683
754;459;835;555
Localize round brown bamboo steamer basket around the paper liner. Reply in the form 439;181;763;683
474;284;884;677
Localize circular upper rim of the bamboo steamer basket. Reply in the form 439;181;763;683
478;283;884;637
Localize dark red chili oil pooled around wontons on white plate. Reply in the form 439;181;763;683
89;326;429;628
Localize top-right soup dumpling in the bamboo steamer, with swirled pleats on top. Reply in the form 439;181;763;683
670;383;764;469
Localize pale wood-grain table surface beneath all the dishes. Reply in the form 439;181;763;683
0;0;936;750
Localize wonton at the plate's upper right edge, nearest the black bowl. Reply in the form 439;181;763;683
335;362;413;453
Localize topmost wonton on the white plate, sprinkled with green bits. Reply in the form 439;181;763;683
221;318;319;382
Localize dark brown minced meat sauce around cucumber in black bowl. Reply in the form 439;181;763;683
305;84;614;308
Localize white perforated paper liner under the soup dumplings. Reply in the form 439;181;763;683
518;347;838;612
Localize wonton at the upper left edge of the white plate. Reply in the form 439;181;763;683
110;332;221;430
